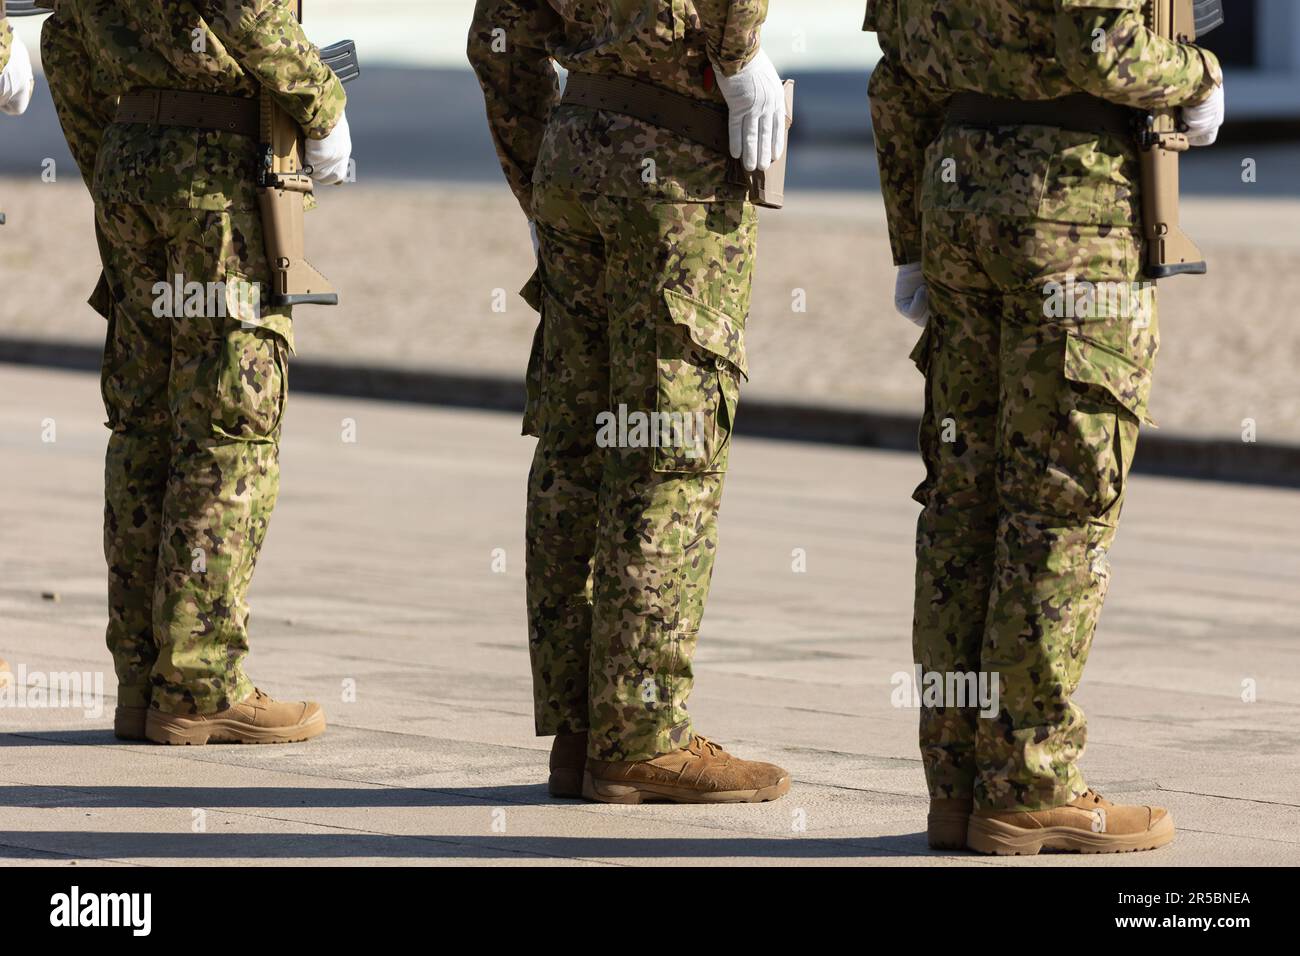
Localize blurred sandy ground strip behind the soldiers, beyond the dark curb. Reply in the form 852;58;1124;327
0;179;1300;442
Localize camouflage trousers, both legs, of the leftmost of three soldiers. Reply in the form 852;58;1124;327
92;203;291;714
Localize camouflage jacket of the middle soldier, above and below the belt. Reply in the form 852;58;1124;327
468;0;767;217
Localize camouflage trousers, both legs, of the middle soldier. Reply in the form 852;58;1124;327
524;185;757;760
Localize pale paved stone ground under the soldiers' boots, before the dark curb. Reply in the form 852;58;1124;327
0;367;1300;866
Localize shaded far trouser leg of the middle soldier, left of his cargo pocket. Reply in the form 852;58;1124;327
525;185;610;738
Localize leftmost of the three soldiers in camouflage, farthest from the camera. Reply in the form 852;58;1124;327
42;0;346;744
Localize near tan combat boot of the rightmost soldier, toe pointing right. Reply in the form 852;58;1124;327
966;790;1174;856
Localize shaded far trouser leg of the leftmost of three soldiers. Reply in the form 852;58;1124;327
95;203;172;708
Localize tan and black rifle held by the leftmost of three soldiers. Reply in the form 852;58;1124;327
257;0;361;306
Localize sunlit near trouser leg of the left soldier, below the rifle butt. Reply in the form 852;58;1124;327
153;209;291;714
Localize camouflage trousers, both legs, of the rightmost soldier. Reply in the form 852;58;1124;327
913;211;1158;810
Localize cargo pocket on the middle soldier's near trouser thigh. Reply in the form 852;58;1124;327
646;289;749;473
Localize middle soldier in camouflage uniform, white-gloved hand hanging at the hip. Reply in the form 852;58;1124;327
468;0;789;803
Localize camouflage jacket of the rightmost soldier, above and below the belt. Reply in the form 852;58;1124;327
865;0;1223;265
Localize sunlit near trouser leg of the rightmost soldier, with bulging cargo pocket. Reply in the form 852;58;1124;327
976;221;1158;810
